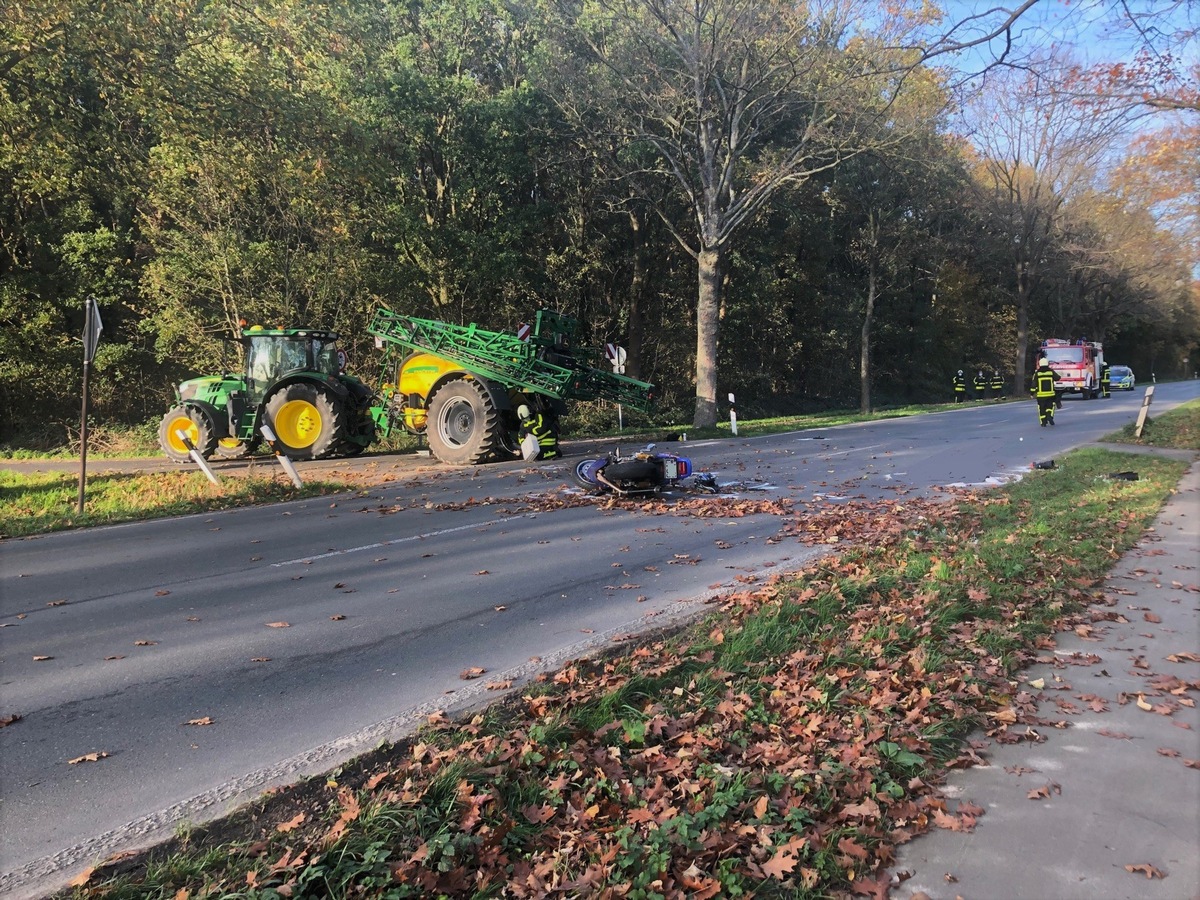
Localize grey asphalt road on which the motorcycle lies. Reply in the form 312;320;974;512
0;382;1200;896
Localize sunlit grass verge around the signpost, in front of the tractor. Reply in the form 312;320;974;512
0;470;350;538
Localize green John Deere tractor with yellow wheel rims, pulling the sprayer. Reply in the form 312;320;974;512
158;326;376;462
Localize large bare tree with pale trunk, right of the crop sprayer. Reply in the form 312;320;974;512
558;0;1037;427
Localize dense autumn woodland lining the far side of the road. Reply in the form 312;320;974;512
0;0;1200;443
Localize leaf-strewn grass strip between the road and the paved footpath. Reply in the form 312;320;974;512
74;420;1198;900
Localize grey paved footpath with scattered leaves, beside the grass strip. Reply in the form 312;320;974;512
889;454;1200;900
